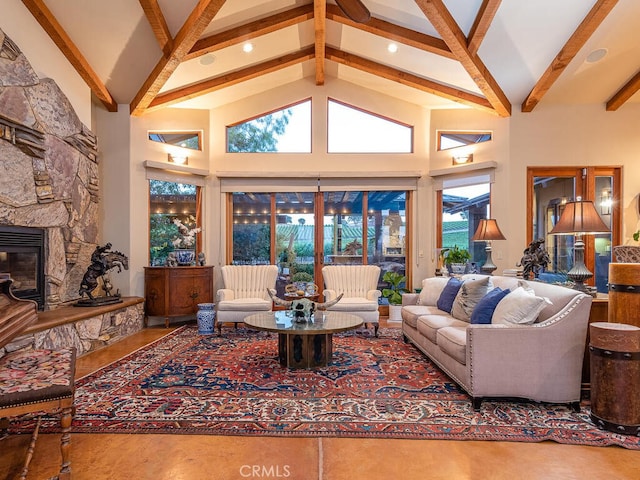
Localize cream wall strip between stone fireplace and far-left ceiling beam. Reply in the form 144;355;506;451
0;0;93;125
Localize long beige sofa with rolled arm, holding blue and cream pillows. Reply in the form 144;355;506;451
402;275;592;409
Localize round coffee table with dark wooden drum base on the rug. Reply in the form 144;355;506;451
244;310;362;368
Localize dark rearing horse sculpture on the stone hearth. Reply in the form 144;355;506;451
74;242;129;307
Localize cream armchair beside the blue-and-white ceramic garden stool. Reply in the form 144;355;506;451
216;265;278;335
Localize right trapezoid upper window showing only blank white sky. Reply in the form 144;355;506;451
328;99;413;153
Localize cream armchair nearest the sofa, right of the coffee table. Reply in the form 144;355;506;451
322;265;382;337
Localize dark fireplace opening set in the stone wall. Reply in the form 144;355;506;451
0;226;45;310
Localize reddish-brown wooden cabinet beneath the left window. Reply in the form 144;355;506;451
144;266;213;327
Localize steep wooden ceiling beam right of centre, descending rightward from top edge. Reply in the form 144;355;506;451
415;0;511;117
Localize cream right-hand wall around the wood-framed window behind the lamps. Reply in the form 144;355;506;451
431;105;640;278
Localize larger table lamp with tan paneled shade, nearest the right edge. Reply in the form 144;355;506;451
549;197;609;292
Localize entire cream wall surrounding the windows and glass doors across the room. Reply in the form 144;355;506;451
97;80;640;295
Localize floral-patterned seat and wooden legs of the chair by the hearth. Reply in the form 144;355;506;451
0;348;76;480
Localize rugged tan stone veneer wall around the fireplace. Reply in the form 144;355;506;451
0;30;100;309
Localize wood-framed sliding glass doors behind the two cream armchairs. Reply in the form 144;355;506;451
227;190;408;294
